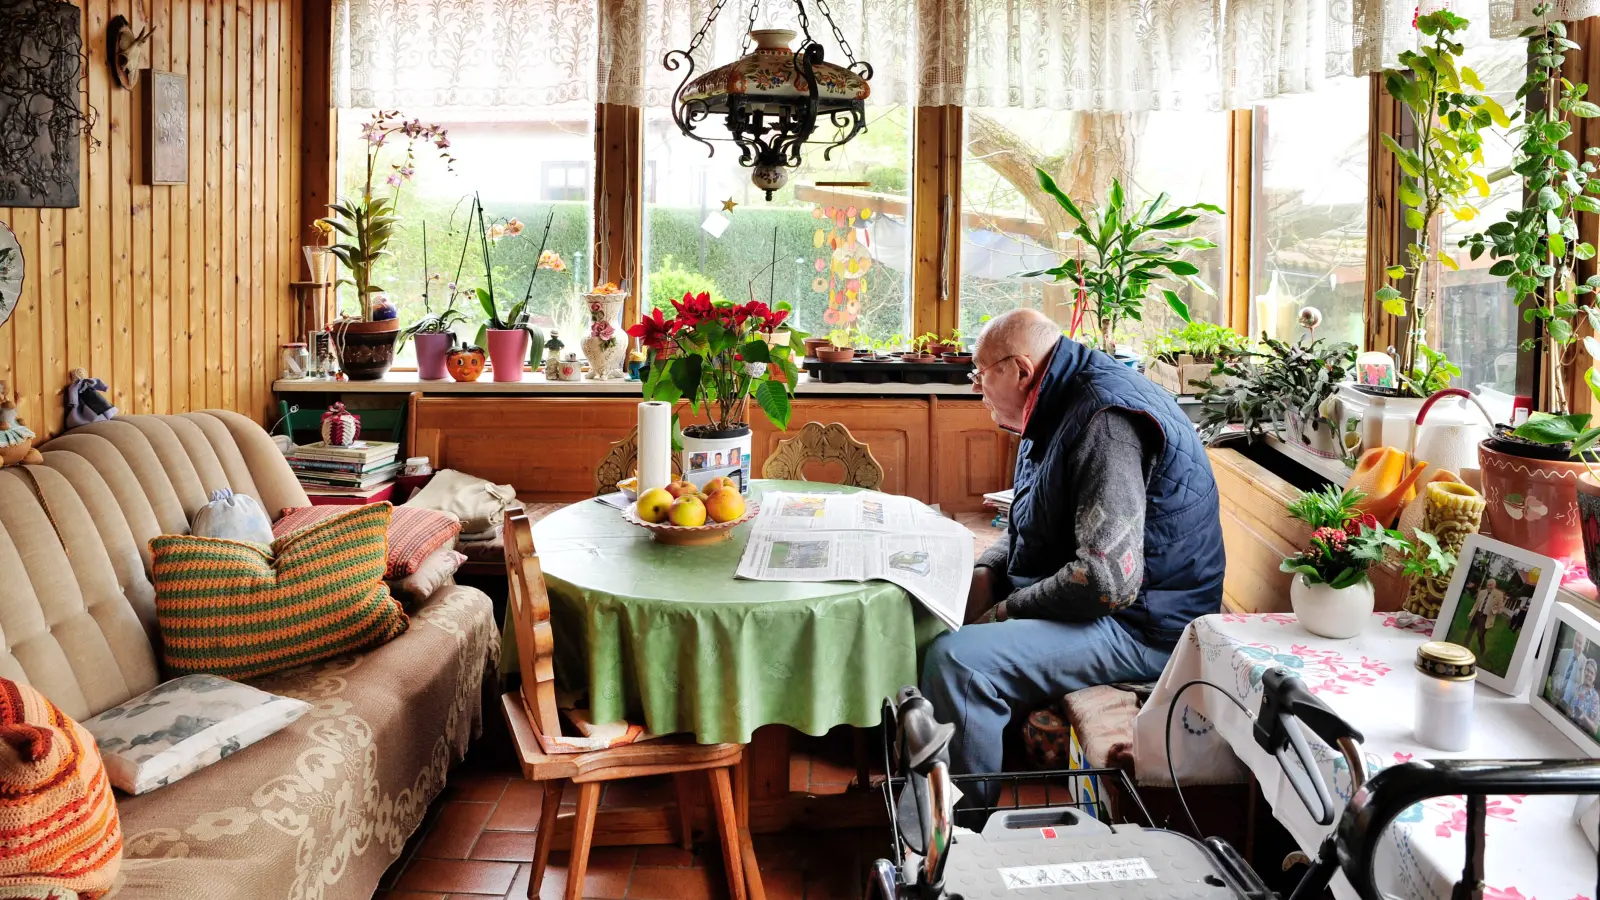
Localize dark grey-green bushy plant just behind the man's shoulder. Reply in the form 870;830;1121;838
1200;333;1355;442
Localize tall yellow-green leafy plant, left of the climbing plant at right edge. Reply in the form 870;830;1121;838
1376;10;1510;390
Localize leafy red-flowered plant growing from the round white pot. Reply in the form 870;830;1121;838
1280;487;1411;589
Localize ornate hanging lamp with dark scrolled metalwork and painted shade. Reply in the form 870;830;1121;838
661;18;872;201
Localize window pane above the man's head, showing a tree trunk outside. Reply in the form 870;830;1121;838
960;107;1227;344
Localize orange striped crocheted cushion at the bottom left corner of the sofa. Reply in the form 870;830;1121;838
0;677;122;897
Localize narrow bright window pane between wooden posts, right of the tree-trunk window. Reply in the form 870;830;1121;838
1250;78;1368;346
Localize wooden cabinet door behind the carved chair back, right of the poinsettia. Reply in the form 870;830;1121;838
750;397;931;503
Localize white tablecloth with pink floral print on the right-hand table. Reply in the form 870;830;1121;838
1134;613;1595;900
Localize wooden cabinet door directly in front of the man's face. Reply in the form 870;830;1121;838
931;397;1016;512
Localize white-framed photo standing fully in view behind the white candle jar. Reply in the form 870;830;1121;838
1434;535;1562;697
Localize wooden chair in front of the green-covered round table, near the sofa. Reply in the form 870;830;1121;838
501;512;766;900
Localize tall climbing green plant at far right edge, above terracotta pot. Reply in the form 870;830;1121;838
1461;3;1600;413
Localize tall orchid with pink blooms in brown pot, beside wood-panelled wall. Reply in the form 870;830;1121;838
318;109;456;320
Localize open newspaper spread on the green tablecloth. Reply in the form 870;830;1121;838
738;490;973;631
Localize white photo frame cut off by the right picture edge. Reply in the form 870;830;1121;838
1528;604;1600;755
